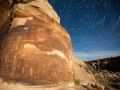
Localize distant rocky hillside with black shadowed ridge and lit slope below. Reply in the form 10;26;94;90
86;56;120;90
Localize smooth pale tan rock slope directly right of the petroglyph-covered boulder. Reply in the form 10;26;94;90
73;57;96;85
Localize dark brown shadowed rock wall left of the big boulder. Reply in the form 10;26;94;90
0;0;12;48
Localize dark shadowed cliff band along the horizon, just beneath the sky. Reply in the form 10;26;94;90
86;56;120;72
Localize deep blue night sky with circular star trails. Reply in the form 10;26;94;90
48;0;120;61
